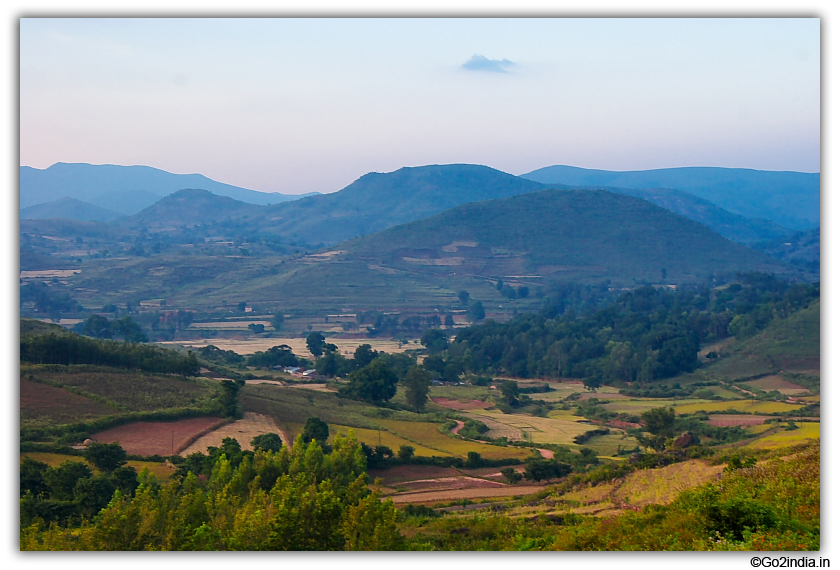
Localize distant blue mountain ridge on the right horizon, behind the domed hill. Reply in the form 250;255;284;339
522;166;820;230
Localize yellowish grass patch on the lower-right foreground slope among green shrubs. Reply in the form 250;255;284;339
613;459;725;507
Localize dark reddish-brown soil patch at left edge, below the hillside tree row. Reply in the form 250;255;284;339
20;379;117;421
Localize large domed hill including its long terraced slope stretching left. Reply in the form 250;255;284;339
60;189;792;312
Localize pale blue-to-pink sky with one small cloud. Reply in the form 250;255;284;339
19;18;820;194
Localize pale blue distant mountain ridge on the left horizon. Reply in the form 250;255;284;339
20;162;310;214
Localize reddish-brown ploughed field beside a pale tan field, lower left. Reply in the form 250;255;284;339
91;417;224;456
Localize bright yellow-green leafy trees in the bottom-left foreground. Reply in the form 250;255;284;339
20;437;404;550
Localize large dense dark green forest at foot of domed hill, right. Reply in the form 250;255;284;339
433;273;820;387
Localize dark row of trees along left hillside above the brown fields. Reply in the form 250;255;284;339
20;333;199;376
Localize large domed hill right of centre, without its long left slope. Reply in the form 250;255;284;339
336;189;783;283
